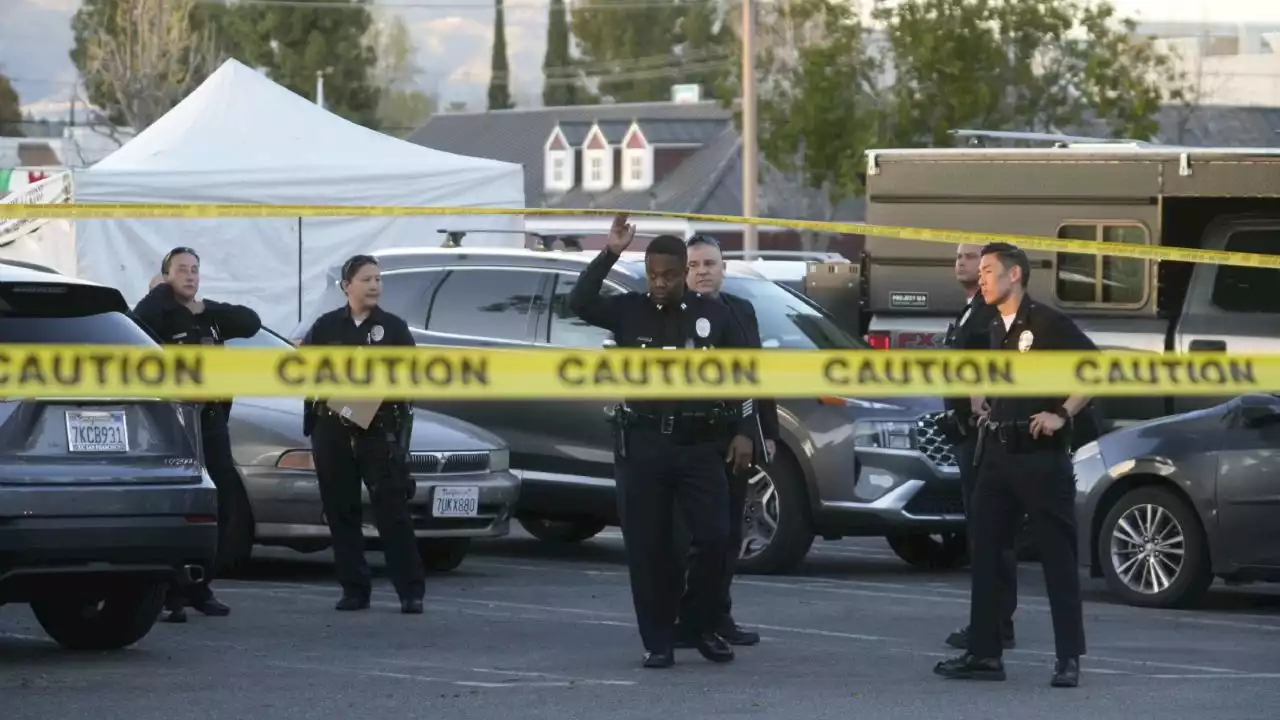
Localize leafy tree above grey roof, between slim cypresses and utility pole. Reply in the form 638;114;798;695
571;0;735;102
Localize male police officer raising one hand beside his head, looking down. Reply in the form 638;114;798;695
568;214;755;667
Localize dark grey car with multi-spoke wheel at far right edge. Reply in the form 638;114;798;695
1074;395;1280;607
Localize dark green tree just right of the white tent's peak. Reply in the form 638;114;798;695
228;0;380;127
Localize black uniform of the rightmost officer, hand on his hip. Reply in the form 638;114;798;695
969;297;1097;659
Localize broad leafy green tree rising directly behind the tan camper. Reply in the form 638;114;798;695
873;0;1181;145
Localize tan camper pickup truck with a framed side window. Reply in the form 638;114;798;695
829;135;1280;427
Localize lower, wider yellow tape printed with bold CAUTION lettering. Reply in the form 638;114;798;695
0;345;1280;400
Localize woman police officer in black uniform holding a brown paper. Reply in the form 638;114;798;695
302;255;425;615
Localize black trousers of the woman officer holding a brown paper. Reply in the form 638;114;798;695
311;415;426;600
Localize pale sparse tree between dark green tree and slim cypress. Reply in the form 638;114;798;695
370;17;436;135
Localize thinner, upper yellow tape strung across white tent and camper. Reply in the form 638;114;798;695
0;202;1280;268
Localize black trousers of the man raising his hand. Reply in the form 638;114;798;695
614;428;730;652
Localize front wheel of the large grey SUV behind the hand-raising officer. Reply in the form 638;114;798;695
736;447;813;575
